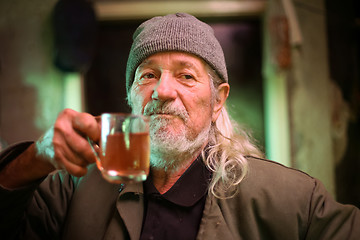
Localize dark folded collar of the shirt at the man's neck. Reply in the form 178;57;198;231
144;155;211;207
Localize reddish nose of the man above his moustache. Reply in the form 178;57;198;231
152;74;177;101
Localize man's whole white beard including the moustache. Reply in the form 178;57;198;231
130;89;211;171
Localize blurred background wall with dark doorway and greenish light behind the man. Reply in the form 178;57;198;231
0;0;360;206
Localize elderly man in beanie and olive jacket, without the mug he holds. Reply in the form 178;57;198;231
0;13;360;239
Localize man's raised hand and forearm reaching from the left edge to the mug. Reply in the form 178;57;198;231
0;109;100;188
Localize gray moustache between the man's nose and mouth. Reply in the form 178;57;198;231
144;101;189;121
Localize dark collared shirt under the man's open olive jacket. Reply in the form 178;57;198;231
140;157;211;240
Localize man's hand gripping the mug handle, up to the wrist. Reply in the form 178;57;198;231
42;109;100;177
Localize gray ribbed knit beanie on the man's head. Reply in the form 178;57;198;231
126;13;228;92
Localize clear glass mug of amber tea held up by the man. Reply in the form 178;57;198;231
88;113;150;183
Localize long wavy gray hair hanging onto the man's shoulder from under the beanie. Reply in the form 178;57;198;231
202;66;263;198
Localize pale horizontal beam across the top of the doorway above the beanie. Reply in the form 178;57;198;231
94;0;266;21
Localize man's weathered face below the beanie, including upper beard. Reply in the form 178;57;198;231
130;52;213;163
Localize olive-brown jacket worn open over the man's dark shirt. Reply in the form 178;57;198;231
0;142;360;240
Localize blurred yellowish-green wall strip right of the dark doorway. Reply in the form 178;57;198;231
264;0;335;195
